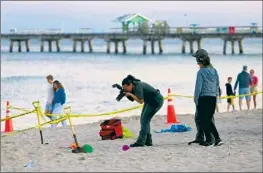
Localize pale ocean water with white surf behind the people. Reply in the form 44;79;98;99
1;39;262;129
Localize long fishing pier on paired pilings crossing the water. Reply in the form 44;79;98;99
1;26;262;54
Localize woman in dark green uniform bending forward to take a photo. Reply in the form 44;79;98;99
122;75;163;147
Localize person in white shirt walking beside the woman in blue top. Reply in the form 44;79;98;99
45;75;54;118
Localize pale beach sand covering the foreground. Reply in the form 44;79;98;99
1;109;262;172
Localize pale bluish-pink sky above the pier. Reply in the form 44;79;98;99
1;1;262;33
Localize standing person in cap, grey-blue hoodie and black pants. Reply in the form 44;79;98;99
193;49;223;146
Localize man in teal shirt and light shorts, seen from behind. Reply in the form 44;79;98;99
234;65;252;110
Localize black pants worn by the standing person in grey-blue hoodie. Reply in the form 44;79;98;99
197;96;220;142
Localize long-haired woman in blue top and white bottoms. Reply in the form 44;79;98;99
51;80;67;128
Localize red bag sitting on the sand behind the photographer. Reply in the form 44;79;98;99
99;118;123;140
